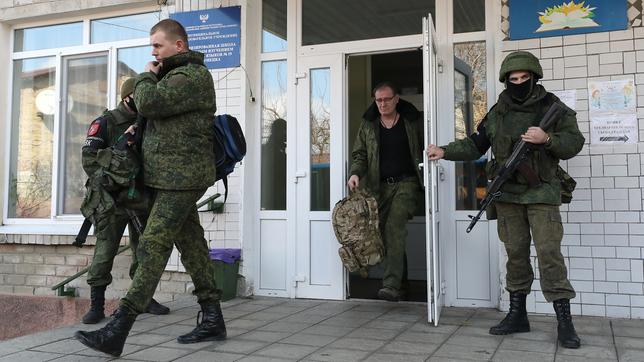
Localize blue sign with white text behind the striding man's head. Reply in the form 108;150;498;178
170;6;241;69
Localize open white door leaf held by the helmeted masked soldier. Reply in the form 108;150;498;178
423;14;443;325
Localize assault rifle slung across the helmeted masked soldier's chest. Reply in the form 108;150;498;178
466;103;566;233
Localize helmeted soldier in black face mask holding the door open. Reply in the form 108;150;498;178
427;51;585;348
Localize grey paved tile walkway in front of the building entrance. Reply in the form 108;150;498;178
0;298;644;362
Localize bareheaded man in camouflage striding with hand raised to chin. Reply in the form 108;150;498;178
75;19;221;356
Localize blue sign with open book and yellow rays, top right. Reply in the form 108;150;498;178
509;0;628;40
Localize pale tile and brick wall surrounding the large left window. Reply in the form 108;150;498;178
0;0;246;300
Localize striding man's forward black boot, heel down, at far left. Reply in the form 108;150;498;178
74;306;136;357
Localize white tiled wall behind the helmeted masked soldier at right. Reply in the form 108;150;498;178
497;1;644;318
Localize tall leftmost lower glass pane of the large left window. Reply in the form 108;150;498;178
8;57;56;218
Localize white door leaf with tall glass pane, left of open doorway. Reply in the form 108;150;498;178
293;54;345;299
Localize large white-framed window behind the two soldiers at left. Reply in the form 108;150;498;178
3;12;159;223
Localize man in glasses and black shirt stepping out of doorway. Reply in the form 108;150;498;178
347;82;423;301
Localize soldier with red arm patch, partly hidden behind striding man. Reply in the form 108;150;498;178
81;78;170;324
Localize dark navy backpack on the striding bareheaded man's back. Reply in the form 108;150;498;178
213;114;246;202
